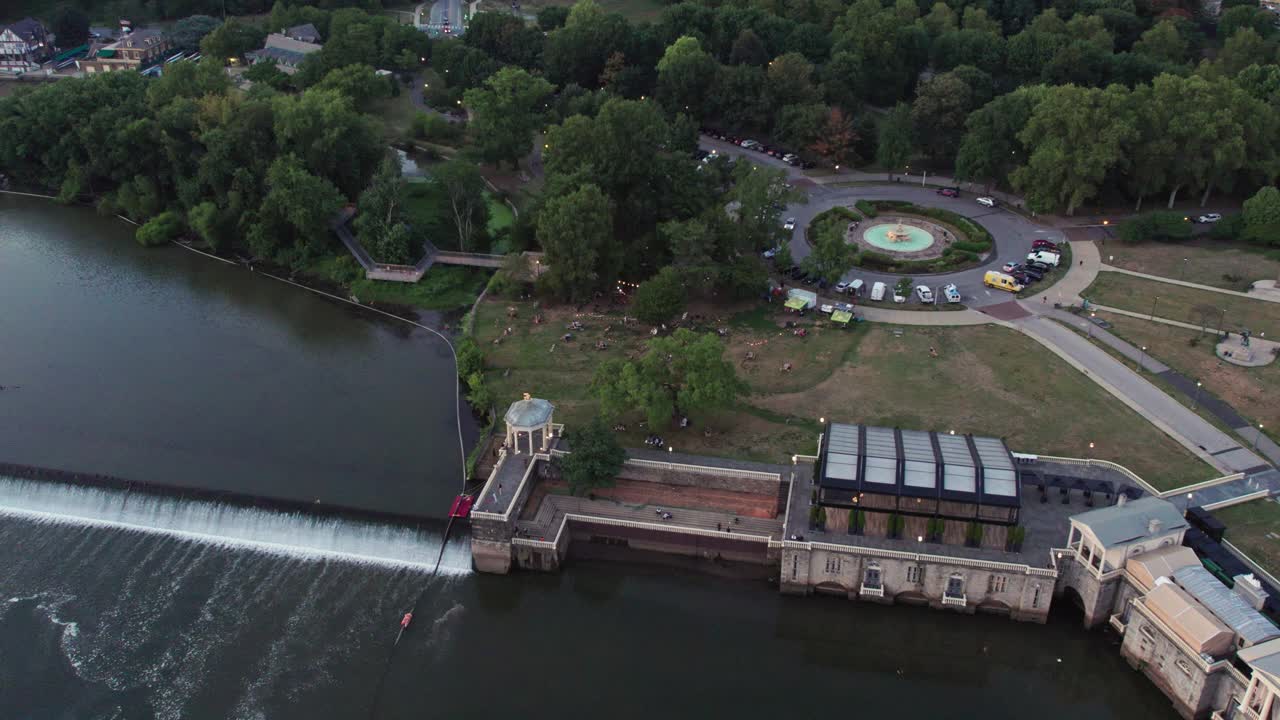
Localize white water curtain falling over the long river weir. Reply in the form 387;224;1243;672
0;477;471;575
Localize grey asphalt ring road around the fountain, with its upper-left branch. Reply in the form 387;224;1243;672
700;136;1065;307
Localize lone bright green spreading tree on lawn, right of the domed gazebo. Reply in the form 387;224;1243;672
591;328;746;429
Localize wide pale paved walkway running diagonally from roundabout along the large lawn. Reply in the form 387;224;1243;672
1011;315;1265;473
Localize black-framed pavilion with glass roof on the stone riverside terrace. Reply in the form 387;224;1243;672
814;423;1021;525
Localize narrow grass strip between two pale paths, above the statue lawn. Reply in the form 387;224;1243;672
1080;273;1280;337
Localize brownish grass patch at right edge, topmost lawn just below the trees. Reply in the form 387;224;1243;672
1101;241;1280;292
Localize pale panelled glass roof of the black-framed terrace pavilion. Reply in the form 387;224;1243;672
818;423;1021;507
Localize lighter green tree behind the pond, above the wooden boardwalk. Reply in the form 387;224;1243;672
463;68;552;167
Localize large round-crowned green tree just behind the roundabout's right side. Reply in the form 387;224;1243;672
1011;85;1138;215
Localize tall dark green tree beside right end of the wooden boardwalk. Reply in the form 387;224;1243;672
538;184;621;302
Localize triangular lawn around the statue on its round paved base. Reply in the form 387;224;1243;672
1100;313;1280;438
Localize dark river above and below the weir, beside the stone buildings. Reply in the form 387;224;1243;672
0;197;1174;720
